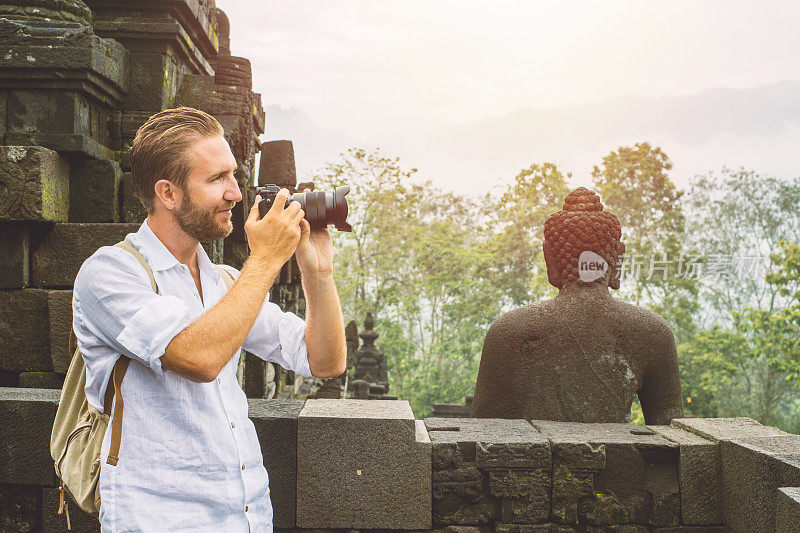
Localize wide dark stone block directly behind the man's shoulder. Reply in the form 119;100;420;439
31;223;139;288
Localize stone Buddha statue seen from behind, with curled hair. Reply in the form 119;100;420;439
470;187;683;425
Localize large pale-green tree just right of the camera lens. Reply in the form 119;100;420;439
315;149;501;416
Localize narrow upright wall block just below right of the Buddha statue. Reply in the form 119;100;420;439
650;426;722;525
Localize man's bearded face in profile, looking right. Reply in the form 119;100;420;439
174;135;242;242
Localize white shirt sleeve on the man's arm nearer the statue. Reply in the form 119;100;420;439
223;265;312;377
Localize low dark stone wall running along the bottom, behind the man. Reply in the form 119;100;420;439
0;388;800;533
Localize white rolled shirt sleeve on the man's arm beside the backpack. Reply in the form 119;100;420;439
72;246;194;375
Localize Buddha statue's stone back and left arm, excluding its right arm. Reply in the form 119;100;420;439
472;286;672;422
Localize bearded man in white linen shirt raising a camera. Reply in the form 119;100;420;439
73;108;346;532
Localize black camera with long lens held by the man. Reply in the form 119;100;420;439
256;185;353;231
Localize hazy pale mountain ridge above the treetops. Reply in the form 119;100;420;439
267;81;800;192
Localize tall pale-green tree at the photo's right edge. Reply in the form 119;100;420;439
679;169;800;431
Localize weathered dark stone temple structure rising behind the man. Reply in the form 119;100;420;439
0;0;304;397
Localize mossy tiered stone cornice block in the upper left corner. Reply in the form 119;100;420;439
0;10;129;159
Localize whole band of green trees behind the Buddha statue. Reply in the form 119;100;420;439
315;143;800;431
